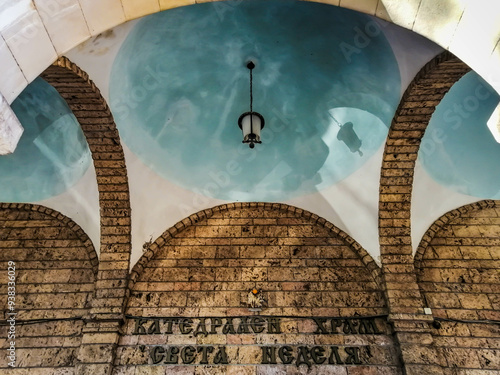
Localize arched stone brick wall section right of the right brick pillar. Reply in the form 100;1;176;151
416;201;500;375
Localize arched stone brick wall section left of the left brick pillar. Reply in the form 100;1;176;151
0;204;97;374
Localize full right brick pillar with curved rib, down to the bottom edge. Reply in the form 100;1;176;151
379;52;470;375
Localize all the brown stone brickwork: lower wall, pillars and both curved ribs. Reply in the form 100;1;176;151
0;48;500;375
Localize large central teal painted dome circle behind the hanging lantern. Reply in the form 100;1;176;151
110;1;401;201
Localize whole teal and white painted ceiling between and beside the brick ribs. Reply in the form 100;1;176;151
0;0;500;261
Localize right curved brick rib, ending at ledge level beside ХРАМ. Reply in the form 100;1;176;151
379;52;470;314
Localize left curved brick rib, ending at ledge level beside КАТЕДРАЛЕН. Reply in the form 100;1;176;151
41;57;131;319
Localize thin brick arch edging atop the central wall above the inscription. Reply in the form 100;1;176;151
129;202;381;290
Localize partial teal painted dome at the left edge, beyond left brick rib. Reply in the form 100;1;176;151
0;78;91;202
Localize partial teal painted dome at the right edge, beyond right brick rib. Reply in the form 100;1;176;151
419;72;500;199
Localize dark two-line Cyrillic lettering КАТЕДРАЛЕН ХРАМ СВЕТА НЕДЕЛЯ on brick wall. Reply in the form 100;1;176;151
133;316;385;367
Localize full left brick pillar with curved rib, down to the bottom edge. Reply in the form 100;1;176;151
42;57;131;375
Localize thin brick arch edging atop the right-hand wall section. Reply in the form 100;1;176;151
415;199;499;269
